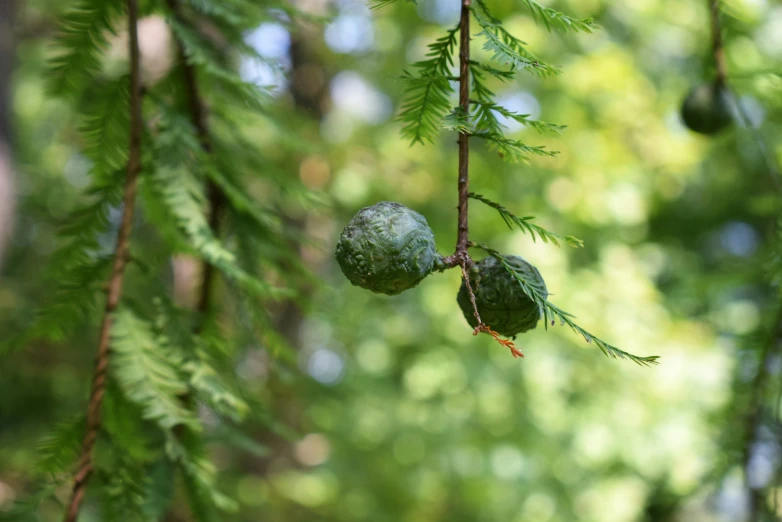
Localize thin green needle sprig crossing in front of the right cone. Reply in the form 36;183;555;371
472;243;659;366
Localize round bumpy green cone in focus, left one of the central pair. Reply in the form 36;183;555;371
336;201;438;295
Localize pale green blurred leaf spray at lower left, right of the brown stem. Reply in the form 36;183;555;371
108;300;248;520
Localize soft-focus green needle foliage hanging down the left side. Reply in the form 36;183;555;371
6;0;306;521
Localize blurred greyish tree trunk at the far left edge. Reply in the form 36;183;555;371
0;0;16;267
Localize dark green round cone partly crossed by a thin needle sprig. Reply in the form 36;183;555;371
456;256;548;337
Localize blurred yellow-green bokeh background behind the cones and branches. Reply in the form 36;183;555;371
0;0;782;522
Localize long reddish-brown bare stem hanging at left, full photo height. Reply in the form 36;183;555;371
65;0;142;522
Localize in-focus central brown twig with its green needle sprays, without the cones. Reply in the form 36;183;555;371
376;0;657;366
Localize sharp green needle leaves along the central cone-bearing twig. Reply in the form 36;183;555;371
386;0;657;366
